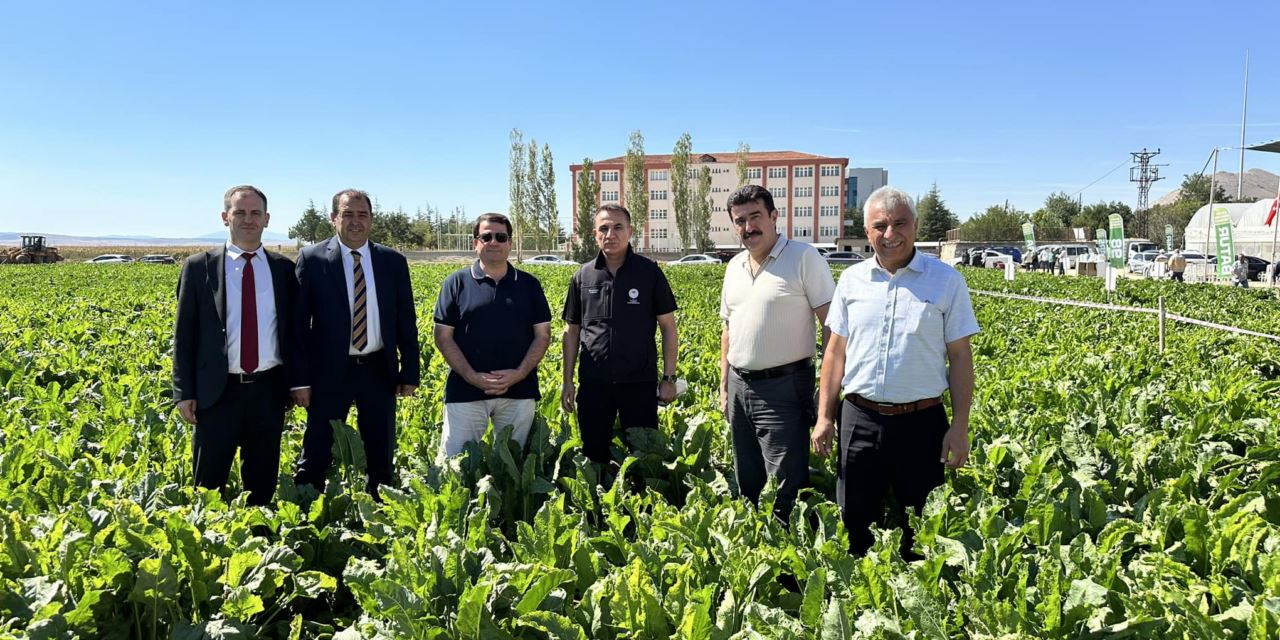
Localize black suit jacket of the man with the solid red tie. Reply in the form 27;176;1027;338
173;246;298;408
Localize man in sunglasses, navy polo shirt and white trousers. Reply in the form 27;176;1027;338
435;214;552;456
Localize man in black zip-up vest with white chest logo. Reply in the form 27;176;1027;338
561;205;680;463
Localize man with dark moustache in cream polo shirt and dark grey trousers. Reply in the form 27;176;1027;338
721;184;836;520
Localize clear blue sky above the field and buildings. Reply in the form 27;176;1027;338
0;0;1280;237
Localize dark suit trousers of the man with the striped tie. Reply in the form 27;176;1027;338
294;352;396;498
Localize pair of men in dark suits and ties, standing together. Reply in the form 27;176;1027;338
173;184;421;504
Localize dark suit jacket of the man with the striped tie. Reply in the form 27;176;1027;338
289;237;421;393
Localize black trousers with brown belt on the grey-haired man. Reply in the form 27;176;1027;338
836;399;950;558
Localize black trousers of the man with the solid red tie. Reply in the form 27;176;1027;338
191;367;285;506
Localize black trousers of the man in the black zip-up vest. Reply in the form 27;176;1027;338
577;381;658;465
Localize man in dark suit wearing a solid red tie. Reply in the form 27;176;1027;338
173;184;297;504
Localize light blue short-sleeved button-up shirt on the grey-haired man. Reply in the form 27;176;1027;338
827;251;978;403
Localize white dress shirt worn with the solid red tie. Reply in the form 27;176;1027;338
223;242;282;374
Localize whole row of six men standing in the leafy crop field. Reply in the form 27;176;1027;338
173;179;978;554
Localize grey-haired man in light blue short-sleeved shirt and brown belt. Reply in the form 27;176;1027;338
812;187;978;559
